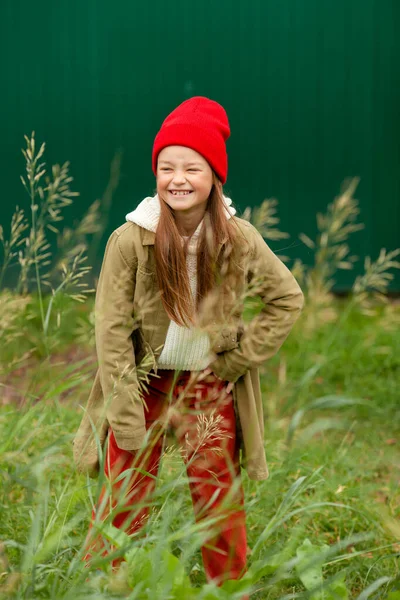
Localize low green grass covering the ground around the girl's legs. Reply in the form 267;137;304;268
0;301;400;600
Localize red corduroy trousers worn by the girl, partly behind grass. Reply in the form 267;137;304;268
85;370;247;585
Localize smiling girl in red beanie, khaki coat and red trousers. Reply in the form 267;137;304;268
74;97;303;584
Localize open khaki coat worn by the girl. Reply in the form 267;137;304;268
74;217;304;480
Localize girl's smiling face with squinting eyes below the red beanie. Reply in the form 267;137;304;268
157;146;213;215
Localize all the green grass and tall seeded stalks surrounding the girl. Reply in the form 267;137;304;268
0;135;400;600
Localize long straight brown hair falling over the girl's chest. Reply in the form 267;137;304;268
154;173;236;326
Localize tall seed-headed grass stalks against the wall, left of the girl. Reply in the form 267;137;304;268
0;132;109;357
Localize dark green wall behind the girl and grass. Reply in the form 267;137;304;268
0;0;400;289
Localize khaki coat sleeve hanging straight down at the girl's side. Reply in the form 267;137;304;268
95;230;146;450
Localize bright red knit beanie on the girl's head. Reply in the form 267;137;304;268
153;96;231;184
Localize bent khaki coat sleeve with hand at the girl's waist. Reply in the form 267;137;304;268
210;228;304;382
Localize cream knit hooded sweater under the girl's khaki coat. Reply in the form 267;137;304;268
126;195;236;371
